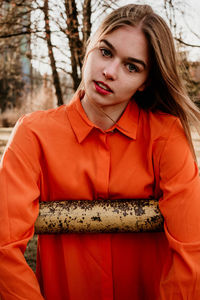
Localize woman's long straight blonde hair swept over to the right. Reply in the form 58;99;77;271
80;4;200;155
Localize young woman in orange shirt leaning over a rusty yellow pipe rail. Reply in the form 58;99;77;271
0;4;200;300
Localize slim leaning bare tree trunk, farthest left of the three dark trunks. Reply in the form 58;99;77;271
43;0;63;106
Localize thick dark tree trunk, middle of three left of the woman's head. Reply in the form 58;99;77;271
65;0;83;90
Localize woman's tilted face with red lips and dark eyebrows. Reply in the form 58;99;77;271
83;26;149;112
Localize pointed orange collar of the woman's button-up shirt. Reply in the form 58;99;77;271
67;95;139;143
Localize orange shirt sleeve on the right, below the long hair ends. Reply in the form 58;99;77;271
159;120;200;300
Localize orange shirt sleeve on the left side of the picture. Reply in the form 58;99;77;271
0;117;44;300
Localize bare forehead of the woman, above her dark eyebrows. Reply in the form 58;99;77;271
100;25;149;63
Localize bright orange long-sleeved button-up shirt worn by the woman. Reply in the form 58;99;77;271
0;98;200;300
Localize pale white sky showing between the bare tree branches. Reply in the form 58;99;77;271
32;0;200;74
